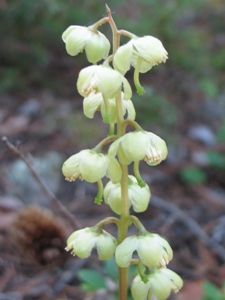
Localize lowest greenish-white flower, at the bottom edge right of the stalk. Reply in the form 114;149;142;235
131;268;183;300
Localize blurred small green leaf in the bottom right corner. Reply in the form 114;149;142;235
201;281;225;300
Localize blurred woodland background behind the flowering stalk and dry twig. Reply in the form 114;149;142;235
0;0;225;300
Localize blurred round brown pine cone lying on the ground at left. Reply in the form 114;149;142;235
11;206;66;265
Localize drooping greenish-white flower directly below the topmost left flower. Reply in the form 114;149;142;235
77;65;132;100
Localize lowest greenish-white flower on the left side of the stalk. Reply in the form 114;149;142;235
66;227;117;260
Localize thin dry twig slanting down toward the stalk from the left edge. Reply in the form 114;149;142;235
2;136;81;228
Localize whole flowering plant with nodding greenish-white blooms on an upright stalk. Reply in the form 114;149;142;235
62;6;183;300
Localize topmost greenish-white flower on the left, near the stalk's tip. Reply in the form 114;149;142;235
62;26;110;64
